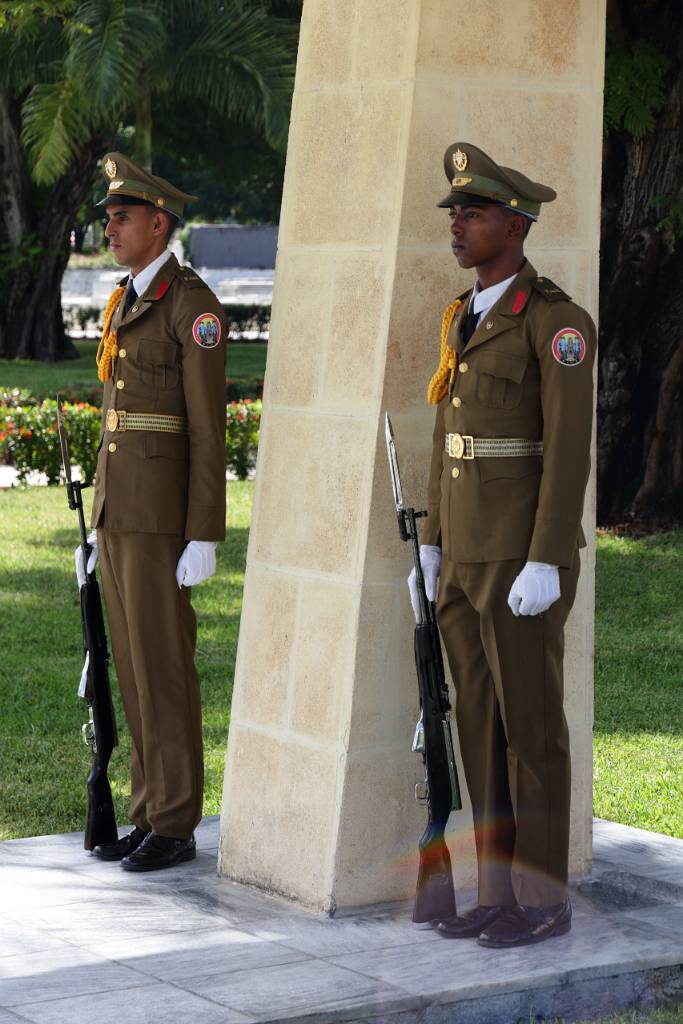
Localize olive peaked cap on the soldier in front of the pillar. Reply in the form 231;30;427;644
436;142;557;220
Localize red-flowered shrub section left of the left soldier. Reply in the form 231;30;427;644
0;398;100;483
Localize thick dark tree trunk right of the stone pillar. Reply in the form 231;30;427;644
597;0;683;527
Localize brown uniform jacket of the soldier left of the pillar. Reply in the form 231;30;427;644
91;256;226;541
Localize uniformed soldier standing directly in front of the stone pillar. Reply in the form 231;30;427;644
409;142;596;947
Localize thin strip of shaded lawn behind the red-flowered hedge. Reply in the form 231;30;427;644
0;341;268;398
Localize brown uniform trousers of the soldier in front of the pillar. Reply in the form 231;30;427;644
437;551;580;906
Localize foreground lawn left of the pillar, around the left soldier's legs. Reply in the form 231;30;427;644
0;482;253;839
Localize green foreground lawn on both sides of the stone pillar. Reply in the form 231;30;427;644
0;482;683;839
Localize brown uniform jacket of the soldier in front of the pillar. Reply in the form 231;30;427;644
422;262;596;567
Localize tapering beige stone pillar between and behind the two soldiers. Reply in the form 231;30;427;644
219;0;605;912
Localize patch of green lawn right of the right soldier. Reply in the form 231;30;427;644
593;530;683;839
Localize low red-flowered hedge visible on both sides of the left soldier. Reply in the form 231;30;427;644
0;388;263;483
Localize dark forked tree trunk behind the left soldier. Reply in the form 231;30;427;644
0;92;106;361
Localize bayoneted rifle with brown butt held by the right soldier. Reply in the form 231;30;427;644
384;413;463;924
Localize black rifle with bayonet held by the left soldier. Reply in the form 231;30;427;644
57;395;119;850
